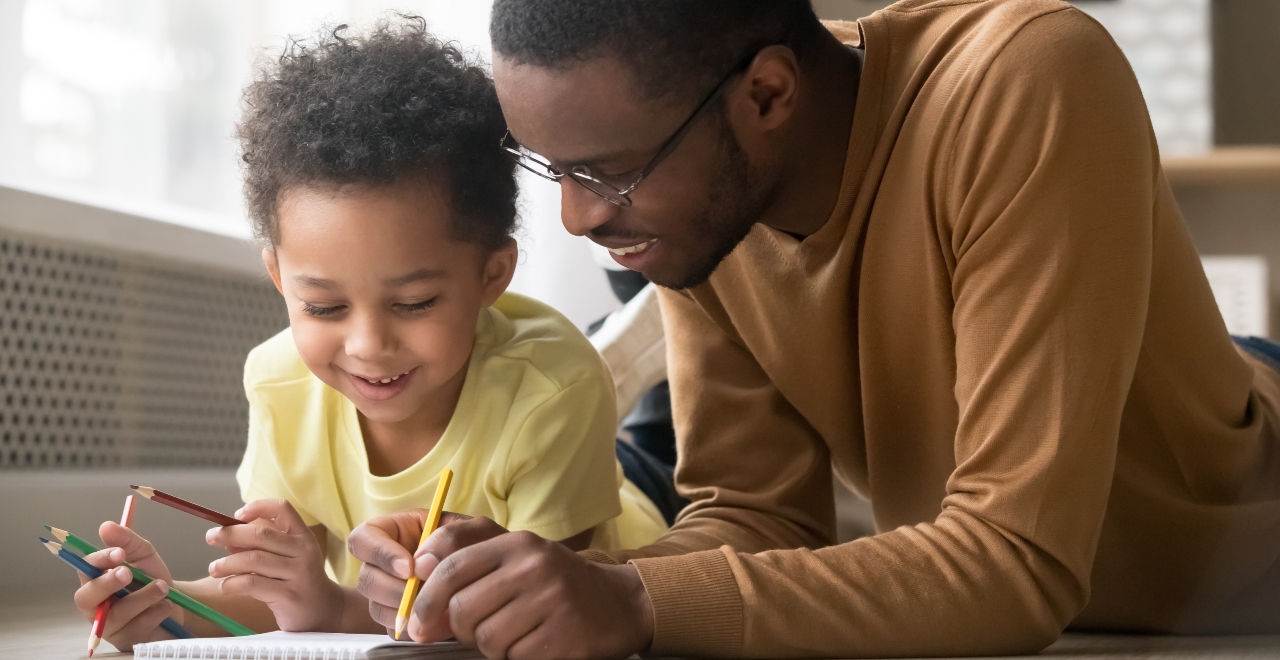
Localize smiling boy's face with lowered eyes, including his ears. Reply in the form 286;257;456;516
264;177;516;423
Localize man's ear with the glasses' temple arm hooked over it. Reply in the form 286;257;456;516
731;46;800;133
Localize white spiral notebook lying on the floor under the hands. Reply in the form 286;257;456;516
133;632;484;660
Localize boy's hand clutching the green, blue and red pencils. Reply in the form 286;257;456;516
76;522;183;651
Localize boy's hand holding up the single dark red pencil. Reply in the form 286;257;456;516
205;500;344;632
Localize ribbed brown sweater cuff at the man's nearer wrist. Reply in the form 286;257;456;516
630;547;744;657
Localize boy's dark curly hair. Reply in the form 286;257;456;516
236;17;516;249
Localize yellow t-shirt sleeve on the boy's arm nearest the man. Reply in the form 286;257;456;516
496;370;622;541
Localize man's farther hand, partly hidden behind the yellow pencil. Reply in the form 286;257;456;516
347;509;481;640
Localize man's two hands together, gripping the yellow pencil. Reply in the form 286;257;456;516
349;512;653;660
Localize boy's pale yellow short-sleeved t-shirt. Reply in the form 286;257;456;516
236;293;666;586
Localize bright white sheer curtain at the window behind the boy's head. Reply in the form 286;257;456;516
0;0;616;326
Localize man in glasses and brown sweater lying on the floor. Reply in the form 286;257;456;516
351;0;1280;659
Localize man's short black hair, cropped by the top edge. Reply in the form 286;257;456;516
489;0;822;98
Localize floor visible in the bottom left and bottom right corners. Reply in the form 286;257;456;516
0;593;1280;660
